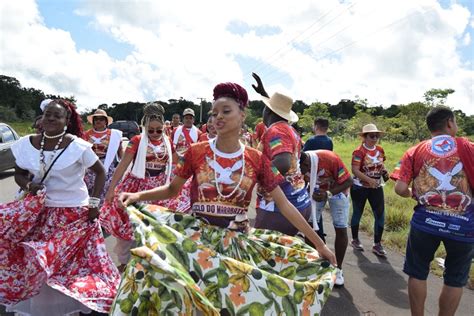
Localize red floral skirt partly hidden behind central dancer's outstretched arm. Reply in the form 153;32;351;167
100;173;191;240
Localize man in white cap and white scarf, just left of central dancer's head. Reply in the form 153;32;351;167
172;108;201;155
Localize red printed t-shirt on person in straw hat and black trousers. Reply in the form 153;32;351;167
352;144;386;188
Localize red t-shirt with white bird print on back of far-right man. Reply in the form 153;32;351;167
391;135;474;242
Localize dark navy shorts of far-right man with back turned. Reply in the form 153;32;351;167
403;227;474;287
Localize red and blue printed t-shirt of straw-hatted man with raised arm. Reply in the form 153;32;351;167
257;121;311;212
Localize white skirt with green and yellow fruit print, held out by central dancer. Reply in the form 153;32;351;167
111;205;335;315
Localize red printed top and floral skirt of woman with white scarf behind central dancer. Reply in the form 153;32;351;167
100;135;190;240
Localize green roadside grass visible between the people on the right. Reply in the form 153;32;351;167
334;140;474;282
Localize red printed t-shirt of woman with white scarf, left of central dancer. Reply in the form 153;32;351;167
125;135;175;176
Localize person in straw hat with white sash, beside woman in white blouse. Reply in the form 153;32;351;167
83;109;122;206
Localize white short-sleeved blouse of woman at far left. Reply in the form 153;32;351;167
12;135;99;207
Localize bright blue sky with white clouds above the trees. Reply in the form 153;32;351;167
0;0;474;115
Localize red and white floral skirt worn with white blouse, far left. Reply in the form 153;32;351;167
0;193;120;312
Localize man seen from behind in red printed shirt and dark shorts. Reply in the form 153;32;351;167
392;106;474;315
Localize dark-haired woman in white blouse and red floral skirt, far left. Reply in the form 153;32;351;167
0;99;120;315
